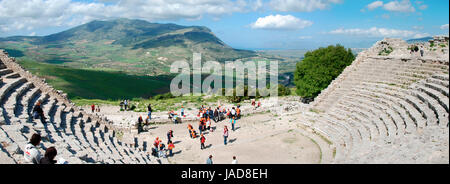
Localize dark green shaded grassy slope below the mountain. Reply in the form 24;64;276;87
19;59;171;100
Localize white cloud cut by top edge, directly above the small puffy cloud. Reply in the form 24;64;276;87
269;0;342;12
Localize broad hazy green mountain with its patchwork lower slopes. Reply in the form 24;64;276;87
0;19;257;76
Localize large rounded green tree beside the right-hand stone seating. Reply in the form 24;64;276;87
294;45;355;98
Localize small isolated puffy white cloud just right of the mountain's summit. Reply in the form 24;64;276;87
250;15;313;30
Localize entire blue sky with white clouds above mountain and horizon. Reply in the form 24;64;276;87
0;0;449;49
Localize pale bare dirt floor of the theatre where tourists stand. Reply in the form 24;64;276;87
84;98;321;164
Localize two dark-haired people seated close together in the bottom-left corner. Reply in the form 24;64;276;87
23;133;67;164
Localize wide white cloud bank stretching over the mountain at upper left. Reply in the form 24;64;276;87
0;0;250;32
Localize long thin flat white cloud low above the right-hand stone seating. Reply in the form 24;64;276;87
329;27;419;38
